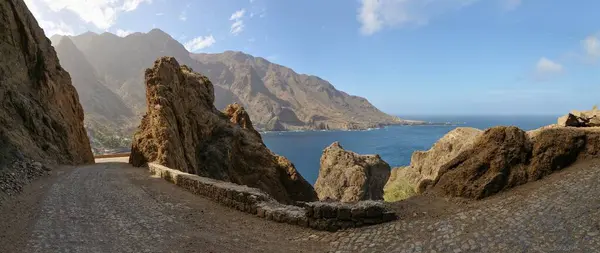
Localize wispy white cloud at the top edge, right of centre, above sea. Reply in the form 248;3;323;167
357;0;478;35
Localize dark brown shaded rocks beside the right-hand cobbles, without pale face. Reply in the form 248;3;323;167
431;127;600;199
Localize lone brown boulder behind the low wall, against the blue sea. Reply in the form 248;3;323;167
315;142;390;202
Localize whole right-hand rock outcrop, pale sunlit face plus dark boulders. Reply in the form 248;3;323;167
386;119;600;200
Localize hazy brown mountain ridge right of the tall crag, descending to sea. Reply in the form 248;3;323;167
192;51;402;130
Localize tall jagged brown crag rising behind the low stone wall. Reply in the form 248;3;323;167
130;57;316;203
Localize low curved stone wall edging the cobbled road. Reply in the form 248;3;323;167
148;163;397;231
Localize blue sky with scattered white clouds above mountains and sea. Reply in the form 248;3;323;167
25;0;600;115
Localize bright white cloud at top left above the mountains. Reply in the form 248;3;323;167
26;0;152;30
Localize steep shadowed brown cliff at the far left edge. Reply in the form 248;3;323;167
0;0;94;167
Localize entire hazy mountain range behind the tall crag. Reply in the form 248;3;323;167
51;29;418;152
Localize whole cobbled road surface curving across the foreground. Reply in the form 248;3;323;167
7;159;600;252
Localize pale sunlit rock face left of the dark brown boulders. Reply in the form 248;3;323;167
385;127;483;196
